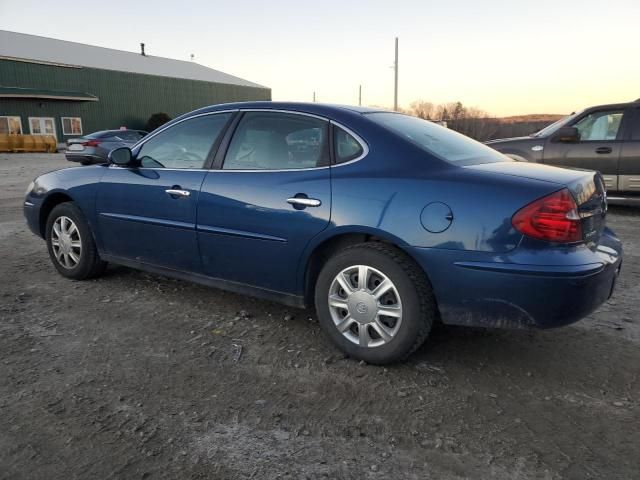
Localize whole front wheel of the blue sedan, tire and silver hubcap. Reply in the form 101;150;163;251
46;202;107;280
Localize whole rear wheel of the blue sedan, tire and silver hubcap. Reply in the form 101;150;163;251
315;242;437;364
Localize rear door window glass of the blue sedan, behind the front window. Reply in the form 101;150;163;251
222;112;328;170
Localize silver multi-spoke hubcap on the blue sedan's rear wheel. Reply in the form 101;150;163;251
329;265;402;347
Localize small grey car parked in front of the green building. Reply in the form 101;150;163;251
65;130;147;165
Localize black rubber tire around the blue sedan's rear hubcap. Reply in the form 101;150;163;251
315;242;437;365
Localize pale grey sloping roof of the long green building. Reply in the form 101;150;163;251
0;30;266;88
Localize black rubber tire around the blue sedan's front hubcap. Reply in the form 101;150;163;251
45;202;107;280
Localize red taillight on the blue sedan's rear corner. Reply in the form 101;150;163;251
511;188;582;243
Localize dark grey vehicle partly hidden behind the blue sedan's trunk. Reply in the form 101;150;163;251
487;99;640;203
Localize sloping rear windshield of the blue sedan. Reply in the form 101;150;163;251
367;112;511;166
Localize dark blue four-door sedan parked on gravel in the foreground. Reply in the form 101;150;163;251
24;102;622;364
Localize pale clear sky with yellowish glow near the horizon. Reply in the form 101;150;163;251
0;0;640;116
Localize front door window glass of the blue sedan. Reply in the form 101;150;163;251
137;113;231;168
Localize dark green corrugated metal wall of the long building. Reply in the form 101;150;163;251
0;59;271;141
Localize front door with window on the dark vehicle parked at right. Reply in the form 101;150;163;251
543;109;625;190
